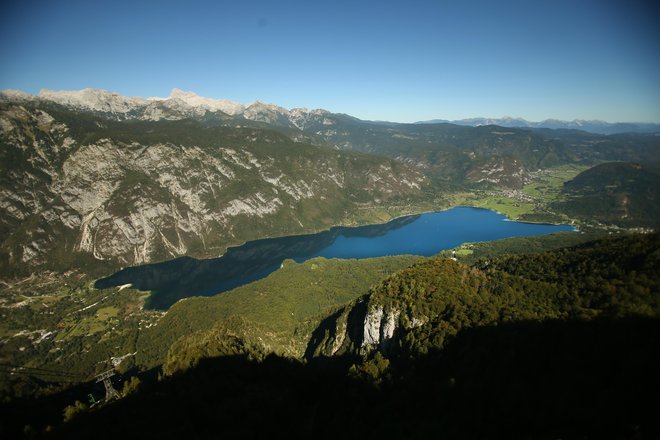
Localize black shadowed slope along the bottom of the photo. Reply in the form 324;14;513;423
40;319;660;439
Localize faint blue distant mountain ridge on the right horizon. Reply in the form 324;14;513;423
416;116;660;134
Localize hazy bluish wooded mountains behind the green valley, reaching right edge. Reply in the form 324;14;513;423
288;114;660;188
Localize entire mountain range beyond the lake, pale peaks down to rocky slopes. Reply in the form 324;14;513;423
0;89;660;271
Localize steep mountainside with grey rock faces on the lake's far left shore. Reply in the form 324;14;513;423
0;102;427;276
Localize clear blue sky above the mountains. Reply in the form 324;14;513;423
0;0;660;122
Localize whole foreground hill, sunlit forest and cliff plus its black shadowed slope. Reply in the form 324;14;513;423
7;234;660;439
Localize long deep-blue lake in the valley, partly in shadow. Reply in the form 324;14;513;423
95;207;574;310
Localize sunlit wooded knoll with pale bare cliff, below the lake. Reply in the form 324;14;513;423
306;258;490;358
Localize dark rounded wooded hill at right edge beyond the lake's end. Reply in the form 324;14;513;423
555;162;660;229
